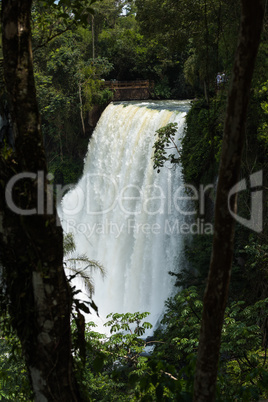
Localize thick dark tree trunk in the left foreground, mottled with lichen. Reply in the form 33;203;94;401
0;0;80;402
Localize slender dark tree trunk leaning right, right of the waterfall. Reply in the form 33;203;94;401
194;0;264;402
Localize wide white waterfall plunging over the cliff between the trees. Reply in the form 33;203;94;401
59;101;190;335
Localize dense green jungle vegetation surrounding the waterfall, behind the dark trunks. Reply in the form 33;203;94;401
0;0;268;401
